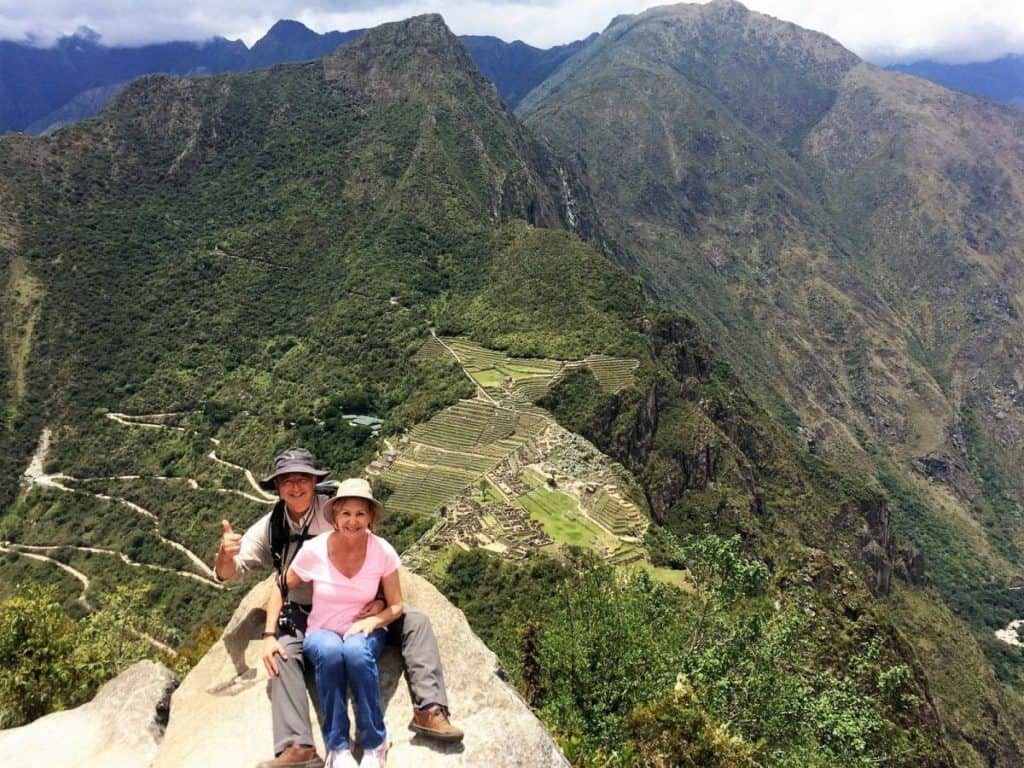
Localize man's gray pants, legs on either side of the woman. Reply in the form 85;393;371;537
270;607;447;755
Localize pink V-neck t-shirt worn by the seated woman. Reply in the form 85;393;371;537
292;531;401;634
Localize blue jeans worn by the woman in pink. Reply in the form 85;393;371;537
302;630;387;750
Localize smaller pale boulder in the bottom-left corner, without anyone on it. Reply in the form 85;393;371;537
0;662;177;768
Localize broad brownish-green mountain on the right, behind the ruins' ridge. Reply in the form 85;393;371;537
517;2;1024;765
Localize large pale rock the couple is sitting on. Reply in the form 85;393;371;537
155;572;568;768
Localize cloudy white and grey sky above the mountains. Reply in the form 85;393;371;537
0;0;1024;63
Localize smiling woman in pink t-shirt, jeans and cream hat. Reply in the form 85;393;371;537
263;477;402;768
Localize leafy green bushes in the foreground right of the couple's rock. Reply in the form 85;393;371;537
441;536;930;768
